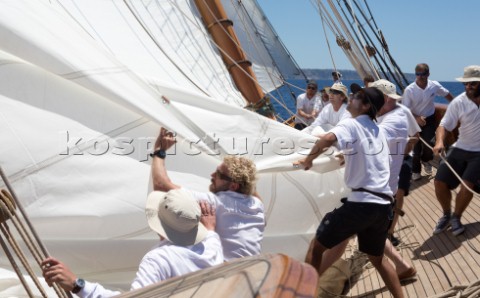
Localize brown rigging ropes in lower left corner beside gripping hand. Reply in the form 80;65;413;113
0;167;72;298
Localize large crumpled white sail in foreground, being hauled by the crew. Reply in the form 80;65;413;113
0;0;347;297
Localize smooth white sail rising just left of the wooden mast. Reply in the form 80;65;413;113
50;0;246;107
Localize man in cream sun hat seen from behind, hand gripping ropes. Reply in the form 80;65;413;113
41;189;223;298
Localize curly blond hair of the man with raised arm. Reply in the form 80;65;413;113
223;155;257;195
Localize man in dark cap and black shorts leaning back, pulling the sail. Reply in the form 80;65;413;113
295;88;403;297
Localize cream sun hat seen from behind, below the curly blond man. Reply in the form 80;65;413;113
145;189;207;246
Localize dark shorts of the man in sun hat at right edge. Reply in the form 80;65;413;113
435;147;480;191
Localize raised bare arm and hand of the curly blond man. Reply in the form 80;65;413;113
152;127;180;191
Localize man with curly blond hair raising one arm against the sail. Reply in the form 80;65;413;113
152;128;265;261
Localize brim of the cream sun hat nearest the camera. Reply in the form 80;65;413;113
145;191;208;246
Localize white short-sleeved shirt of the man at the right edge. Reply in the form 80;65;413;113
440;92;480;152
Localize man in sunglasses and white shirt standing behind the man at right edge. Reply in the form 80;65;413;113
402;63;453;180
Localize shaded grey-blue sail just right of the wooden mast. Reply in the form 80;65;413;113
222;0;304;92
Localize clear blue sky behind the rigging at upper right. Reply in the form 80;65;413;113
257;0;480;81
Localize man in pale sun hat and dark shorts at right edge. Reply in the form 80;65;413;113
433;65;480;236
